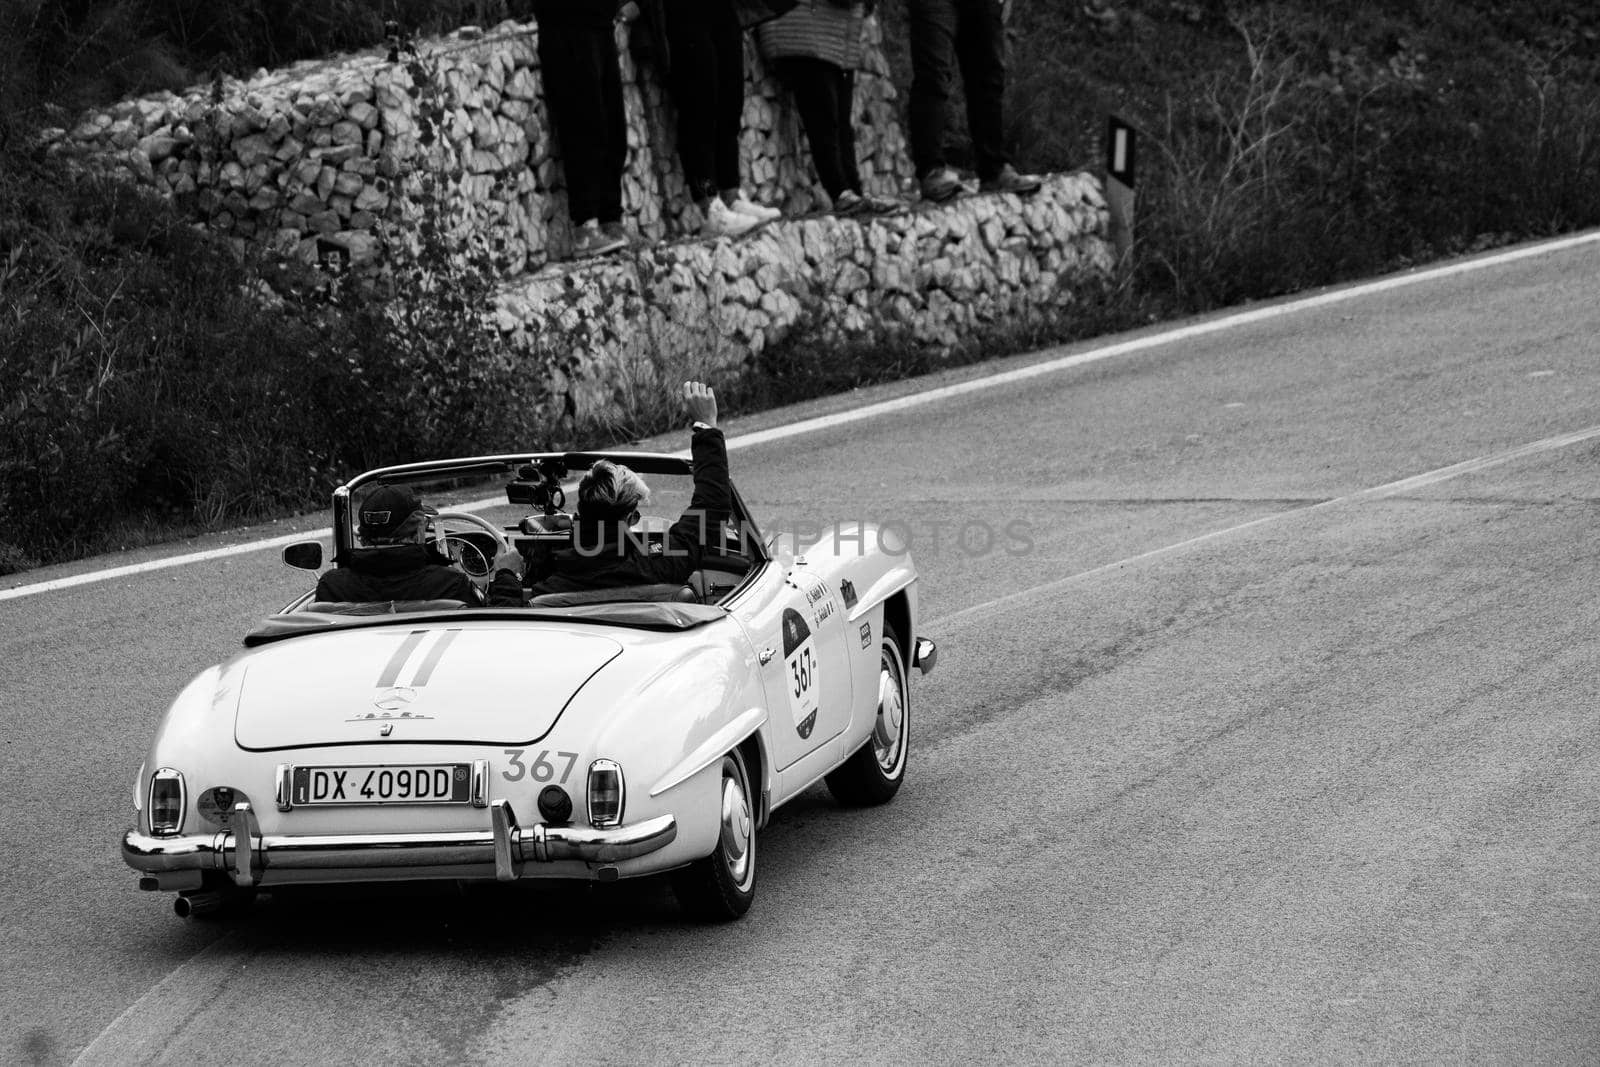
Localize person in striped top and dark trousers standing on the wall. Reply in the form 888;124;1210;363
755;0;899;214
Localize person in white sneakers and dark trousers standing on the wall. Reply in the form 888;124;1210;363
645;0;790;237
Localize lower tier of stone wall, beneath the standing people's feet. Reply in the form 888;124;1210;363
496;174;1112;418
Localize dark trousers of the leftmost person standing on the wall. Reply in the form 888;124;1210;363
534;0;627;222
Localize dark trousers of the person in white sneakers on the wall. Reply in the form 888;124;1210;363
664;0;744;200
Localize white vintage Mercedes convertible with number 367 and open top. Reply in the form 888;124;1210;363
123;453;936;918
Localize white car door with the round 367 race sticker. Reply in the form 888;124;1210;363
730;560;851;771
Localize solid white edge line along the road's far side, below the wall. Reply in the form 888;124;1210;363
0;230;1600;600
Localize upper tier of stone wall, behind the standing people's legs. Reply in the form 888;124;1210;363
48;19;910;275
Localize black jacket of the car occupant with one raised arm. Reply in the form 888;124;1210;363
490;427;733;606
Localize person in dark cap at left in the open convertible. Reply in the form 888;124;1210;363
314;483;483;608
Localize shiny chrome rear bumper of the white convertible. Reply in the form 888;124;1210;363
122;800;678;886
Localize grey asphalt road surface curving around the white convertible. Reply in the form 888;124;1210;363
9;245;1600;1065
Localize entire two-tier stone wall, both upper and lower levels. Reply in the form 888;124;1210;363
46;19;1110;413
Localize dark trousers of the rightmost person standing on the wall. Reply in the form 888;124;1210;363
909;0;1010;179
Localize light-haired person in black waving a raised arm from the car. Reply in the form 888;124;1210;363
490;381;733;605
